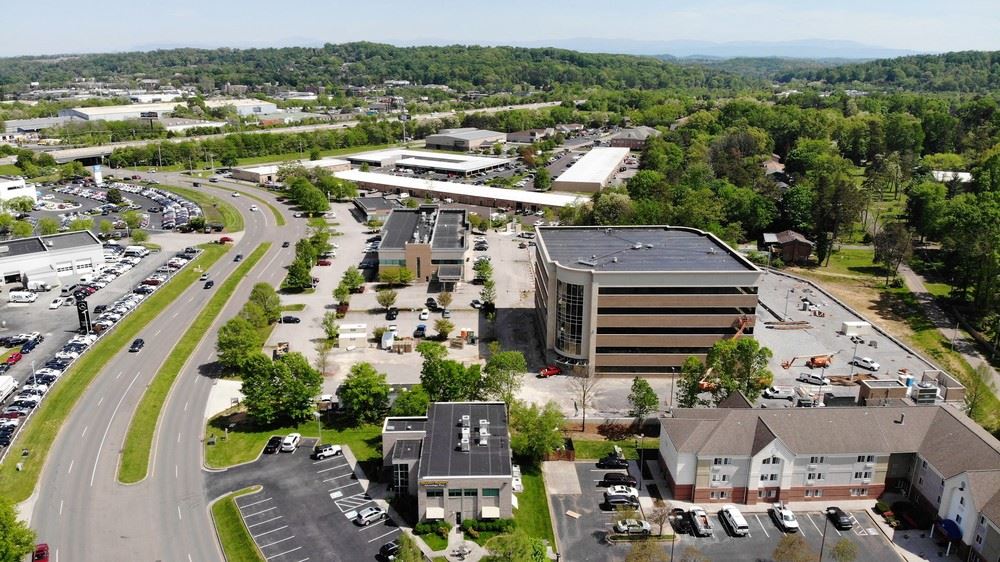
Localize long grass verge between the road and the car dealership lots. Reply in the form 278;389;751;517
0;244;228;496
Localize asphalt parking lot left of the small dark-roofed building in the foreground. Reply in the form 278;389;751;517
208;439;400;562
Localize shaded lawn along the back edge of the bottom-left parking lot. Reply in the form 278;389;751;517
205;407;382;468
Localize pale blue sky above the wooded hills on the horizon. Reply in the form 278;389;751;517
0;0;1000;56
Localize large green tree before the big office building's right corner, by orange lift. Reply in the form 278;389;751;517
708;338;774;402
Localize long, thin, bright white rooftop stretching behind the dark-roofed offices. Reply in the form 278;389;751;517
334;170;586;210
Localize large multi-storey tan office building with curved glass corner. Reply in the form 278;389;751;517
533;226;763;375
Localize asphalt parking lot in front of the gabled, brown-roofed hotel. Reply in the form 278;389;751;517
546;461;897;562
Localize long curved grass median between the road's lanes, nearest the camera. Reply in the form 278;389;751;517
118;242;271;484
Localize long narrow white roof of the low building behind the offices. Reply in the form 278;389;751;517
333;170;587;207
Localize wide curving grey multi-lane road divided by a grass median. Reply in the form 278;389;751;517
31;174;306;562
